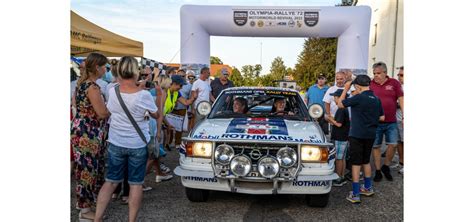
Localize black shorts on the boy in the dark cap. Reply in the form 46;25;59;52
349;136;374;165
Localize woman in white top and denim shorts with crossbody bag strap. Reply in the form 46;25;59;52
95;56;160;221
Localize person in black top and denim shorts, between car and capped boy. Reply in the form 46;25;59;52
329;89;350;187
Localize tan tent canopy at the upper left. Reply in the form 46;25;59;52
71;11;143;57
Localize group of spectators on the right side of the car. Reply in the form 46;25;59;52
305;62;404;203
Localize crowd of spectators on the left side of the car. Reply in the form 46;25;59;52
71;53;233;221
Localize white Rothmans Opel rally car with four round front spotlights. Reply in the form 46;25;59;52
174;87;338;207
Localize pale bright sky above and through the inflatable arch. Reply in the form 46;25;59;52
71;0;340;73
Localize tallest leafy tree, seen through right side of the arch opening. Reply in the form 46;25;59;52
293;38;337;89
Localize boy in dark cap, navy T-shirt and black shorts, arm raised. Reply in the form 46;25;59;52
337;75;384;203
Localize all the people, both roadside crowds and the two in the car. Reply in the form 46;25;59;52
71;53;404;221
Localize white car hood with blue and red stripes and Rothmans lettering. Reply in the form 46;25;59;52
189;118;325;143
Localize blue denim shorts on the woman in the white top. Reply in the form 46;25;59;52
105;143;148;185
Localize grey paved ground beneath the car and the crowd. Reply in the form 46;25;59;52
71;146;403;221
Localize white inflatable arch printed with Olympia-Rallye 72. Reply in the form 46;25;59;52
180;5;371;74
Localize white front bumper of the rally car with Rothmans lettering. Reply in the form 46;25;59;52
174;166;339;194
